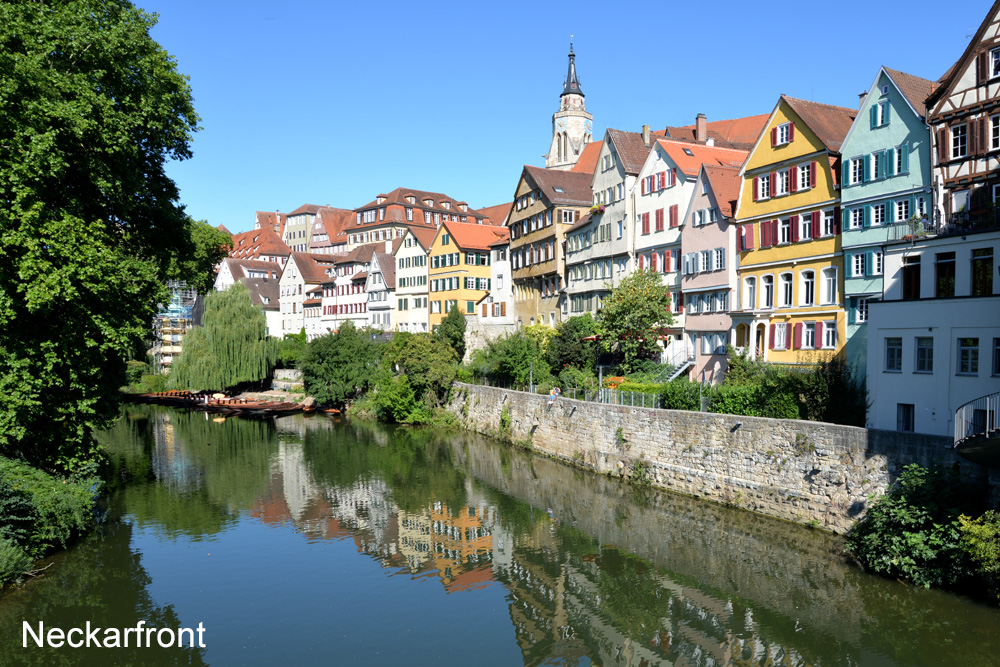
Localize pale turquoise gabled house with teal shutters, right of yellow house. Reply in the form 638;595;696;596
840;67;933;373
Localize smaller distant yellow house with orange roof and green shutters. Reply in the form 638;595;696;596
428;222;509;331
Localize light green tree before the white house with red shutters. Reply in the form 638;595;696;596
597;270;674;372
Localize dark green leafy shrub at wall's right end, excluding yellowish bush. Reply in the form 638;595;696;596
847;463;973;587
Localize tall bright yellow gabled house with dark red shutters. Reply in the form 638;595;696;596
732;95;857;364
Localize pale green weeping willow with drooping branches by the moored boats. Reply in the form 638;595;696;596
170;283;278;390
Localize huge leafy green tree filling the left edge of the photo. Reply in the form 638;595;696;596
0;0;198;472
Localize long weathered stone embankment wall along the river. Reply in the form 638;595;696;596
448;383;1000;533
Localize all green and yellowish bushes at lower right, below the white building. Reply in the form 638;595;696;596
847;463;1000;603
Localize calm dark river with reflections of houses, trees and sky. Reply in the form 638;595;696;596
0;406;1000;667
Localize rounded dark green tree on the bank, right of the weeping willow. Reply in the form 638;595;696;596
299;321;383;407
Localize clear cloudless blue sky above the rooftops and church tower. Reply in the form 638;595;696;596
137;0;992;232
